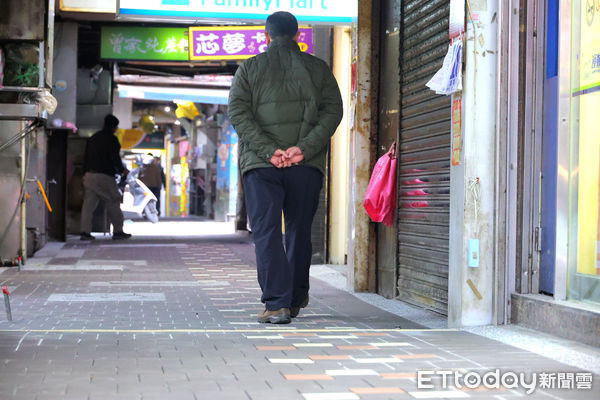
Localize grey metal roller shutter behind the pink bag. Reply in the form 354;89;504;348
398;0;451;314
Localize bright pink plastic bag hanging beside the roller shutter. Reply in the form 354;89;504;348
363;142;396;226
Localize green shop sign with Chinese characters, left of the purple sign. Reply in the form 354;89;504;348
100;26;189;61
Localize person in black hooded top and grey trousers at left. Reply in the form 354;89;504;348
80;114;131;240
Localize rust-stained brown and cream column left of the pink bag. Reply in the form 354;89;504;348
348;0;379;292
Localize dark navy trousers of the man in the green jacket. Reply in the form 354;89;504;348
244;166;323;310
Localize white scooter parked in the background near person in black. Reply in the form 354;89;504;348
120;168;158;224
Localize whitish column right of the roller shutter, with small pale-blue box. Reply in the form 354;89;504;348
448;0;498;327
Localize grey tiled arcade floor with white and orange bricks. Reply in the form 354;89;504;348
0;228;600;400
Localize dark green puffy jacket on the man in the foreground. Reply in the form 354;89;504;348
228;37;343;174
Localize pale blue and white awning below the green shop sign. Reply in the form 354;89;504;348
117;85;229;104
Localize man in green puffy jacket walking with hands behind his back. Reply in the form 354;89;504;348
228;11;343;324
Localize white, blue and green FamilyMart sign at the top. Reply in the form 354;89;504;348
117;0;358;25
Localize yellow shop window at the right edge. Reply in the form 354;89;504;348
559;0;600;304
